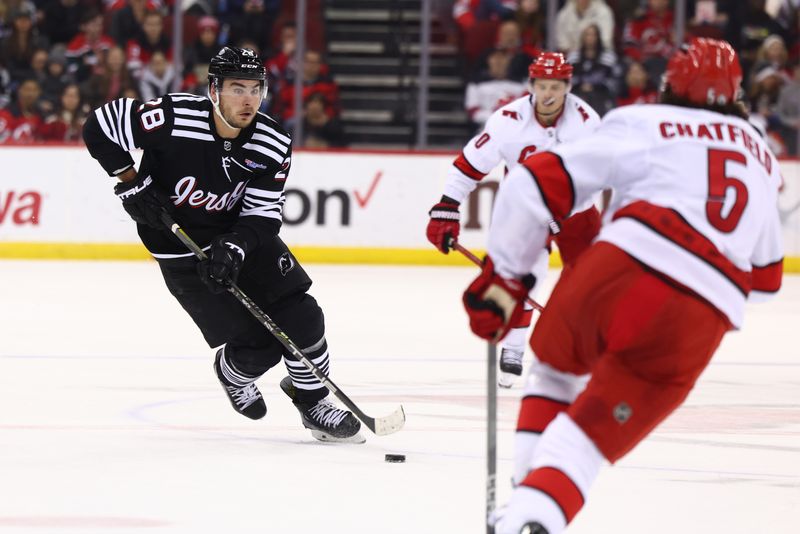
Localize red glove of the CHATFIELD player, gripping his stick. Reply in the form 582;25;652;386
463;256;536;343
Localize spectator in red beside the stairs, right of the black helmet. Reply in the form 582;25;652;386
276;49;339;130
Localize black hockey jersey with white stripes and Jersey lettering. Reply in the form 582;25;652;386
84;93;292;259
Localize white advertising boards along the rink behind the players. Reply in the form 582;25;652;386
0;147;800;262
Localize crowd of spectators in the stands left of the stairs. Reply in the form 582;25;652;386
0;0;344;147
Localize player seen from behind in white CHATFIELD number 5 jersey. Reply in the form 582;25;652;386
464;39;783;534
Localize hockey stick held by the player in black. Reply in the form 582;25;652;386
161;212;406;436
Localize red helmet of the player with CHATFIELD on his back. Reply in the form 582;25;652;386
664;38;742;106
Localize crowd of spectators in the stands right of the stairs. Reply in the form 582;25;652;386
462;0;800;155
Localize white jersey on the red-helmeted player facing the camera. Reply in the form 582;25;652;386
444;94;600;202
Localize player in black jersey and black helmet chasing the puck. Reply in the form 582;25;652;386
83;47;364;443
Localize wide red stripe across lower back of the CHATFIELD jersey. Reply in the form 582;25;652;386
614;200;753;296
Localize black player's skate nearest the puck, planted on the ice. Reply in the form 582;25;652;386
281;376;366;443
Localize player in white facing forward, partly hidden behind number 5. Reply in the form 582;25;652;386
427;52;600;387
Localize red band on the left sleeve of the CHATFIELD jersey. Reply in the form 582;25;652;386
522;152;575;222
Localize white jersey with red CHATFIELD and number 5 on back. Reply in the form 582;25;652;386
488;105;783;328
